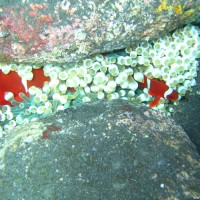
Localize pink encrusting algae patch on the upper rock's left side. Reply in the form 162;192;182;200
0;4;53;56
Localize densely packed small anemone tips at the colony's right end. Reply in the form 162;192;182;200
132;25;200;90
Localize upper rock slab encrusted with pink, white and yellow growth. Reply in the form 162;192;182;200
0;0;200;64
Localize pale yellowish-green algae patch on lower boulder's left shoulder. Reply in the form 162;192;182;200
0;122;46;168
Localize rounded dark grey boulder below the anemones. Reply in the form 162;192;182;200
0;100;200;200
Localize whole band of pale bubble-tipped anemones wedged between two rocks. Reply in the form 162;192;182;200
0;25;200;132
